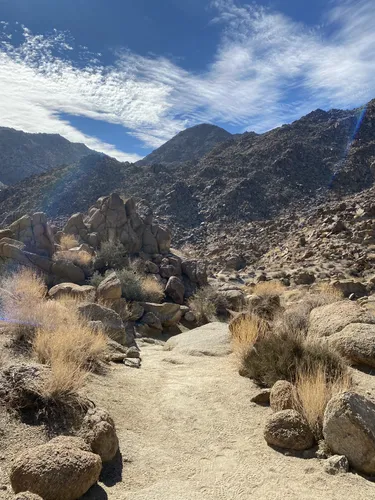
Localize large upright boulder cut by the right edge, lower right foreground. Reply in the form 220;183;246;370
323;392;375;475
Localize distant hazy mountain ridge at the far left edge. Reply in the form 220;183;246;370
0;127;93;185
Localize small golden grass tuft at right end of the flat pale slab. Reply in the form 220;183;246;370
229;314;269;353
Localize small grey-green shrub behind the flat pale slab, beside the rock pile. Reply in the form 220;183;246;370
189;286;229;325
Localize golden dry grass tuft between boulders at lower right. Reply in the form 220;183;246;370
295;365;352;440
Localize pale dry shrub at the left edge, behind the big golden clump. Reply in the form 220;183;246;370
0;268;47;339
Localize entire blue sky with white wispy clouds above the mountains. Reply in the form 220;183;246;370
0;0;375;161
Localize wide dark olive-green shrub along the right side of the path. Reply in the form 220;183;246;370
240;332;347;387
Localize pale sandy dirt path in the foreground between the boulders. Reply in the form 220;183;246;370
85;344;375;500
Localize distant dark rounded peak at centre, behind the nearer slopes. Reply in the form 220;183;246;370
137;123;232;165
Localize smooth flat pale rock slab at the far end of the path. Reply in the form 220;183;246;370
164;322;232;356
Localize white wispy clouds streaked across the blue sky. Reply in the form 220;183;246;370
0;0;375;161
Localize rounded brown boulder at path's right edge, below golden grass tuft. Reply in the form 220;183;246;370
264;410;314;450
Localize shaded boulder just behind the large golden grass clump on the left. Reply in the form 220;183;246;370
78;302;126;345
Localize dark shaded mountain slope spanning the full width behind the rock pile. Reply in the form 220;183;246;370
0;101;375;260
